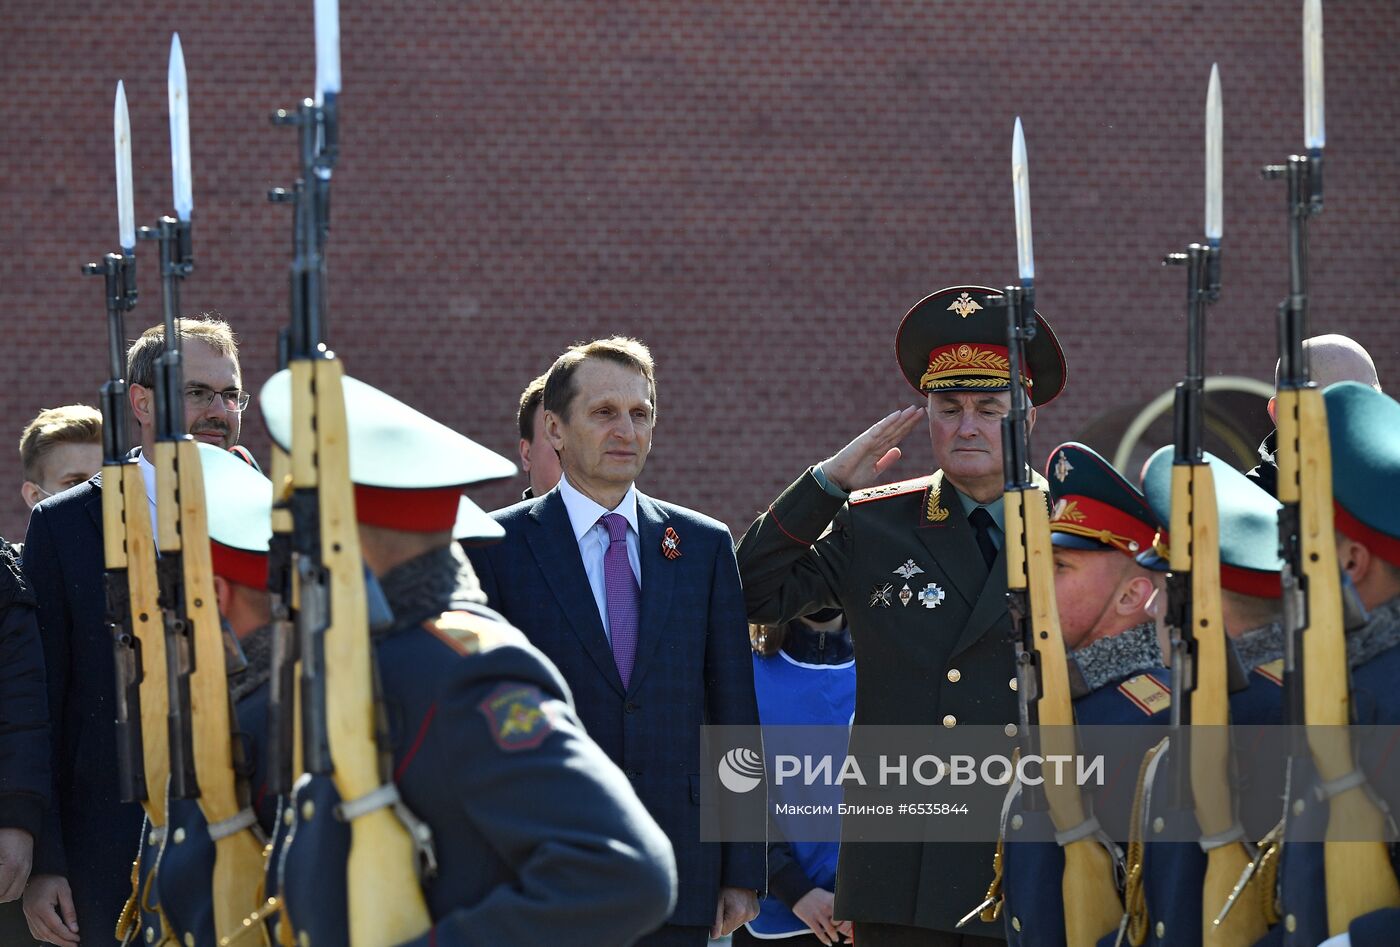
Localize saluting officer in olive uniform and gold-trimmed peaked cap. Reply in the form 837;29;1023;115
738;286;1065;947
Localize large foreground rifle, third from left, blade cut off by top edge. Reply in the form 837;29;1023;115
269;4;431;947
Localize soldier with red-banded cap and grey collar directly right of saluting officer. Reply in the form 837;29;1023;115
1001;443;1172;947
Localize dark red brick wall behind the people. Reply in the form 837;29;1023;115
0;0;1400;537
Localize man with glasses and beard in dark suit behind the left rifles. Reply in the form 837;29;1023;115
24;317;248;947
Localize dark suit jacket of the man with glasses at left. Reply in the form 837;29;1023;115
24;474;143;943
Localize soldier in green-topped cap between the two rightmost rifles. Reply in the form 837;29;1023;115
1138;447;1284;724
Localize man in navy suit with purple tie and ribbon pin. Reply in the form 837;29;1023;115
469;339;766;944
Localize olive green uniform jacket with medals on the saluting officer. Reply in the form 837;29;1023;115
738;469;1043;937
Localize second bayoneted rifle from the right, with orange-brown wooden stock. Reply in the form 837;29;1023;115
1162;66;1268;947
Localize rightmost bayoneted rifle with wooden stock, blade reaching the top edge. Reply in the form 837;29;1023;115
1263;0;1400;934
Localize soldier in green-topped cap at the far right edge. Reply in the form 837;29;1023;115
1271;381;1400;947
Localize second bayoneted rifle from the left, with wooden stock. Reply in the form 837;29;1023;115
143;34;270;930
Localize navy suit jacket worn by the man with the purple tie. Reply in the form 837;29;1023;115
468;489;767;926
